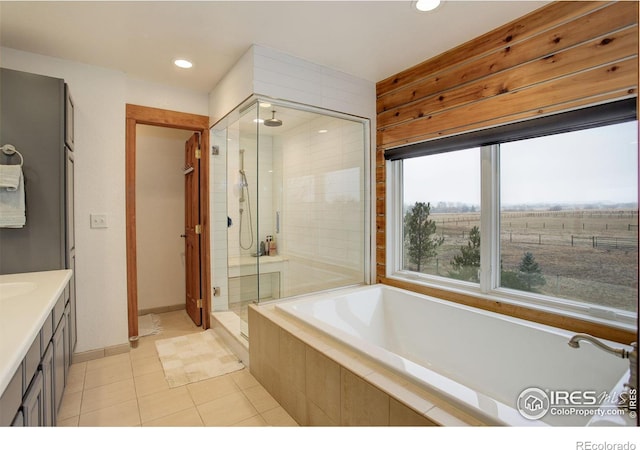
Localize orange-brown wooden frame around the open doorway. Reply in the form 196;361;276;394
125;103;211;337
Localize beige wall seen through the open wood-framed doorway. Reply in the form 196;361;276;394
136;125;192;310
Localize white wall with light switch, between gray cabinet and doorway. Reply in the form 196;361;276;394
0;47;208;352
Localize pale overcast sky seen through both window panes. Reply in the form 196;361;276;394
403;122;638;205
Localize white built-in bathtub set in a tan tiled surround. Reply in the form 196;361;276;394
276;285;634;426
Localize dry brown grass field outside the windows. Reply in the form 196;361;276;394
412;209;638;311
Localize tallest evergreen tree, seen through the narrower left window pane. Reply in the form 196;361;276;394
404;202;444;272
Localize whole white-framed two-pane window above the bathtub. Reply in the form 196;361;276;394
388;107;638;325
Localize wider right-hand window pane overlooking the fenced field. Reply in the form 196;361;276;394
500;122;638;311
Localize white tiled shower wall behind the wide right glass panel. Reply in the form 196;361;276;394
274;116;366;296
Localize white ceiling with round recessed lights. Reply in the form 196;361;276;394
0;0;548;92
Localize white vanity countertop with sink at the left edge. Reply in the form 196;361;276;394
0;270;72;395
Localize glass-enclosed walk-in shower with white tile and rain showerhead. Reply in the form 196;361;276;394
211;99;370;338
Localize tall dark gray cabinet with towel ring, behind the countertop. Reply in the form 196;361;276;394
0;68;77;361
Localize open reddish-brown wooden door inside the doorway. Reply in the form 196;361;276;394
184;133;202;326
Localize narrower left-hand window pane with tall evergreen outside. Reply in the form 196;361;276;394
402;148;480;282
